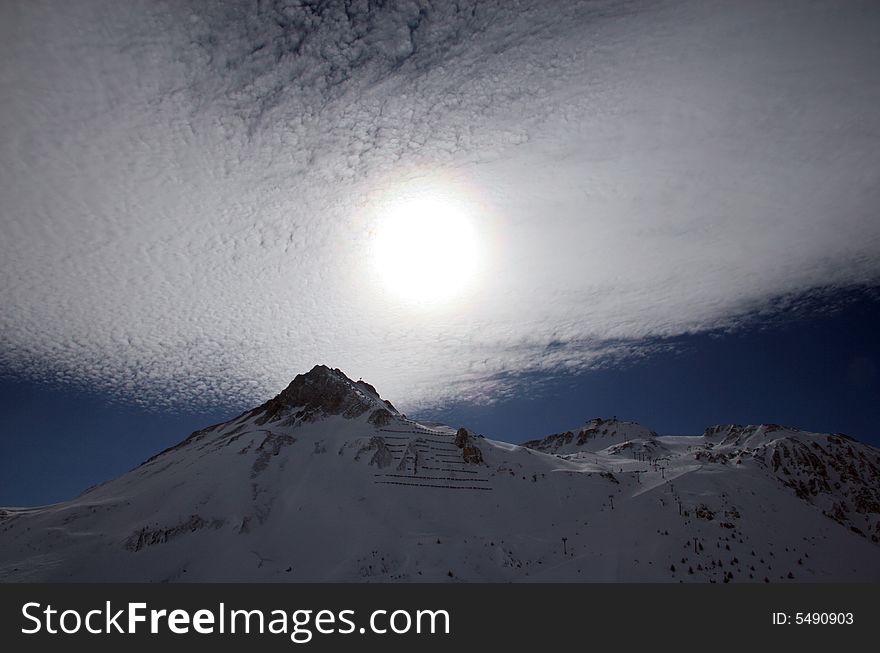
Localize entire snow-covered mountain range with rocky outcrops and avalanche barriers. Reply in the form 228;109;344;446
0;366;880;582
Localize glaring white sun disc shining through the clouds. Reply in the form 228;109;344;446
373;186;479;305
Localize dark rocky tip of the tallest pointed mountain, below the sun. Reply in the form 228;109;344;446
249;365;397;424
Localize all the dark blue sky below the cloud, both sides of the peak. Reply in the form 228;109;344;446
0;292;880;506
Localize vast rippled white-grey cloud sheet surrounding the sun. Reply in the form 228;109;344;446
0;0;880;406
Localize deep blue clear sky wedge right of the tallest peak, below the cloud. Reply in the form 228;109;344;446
426;293;880;446
